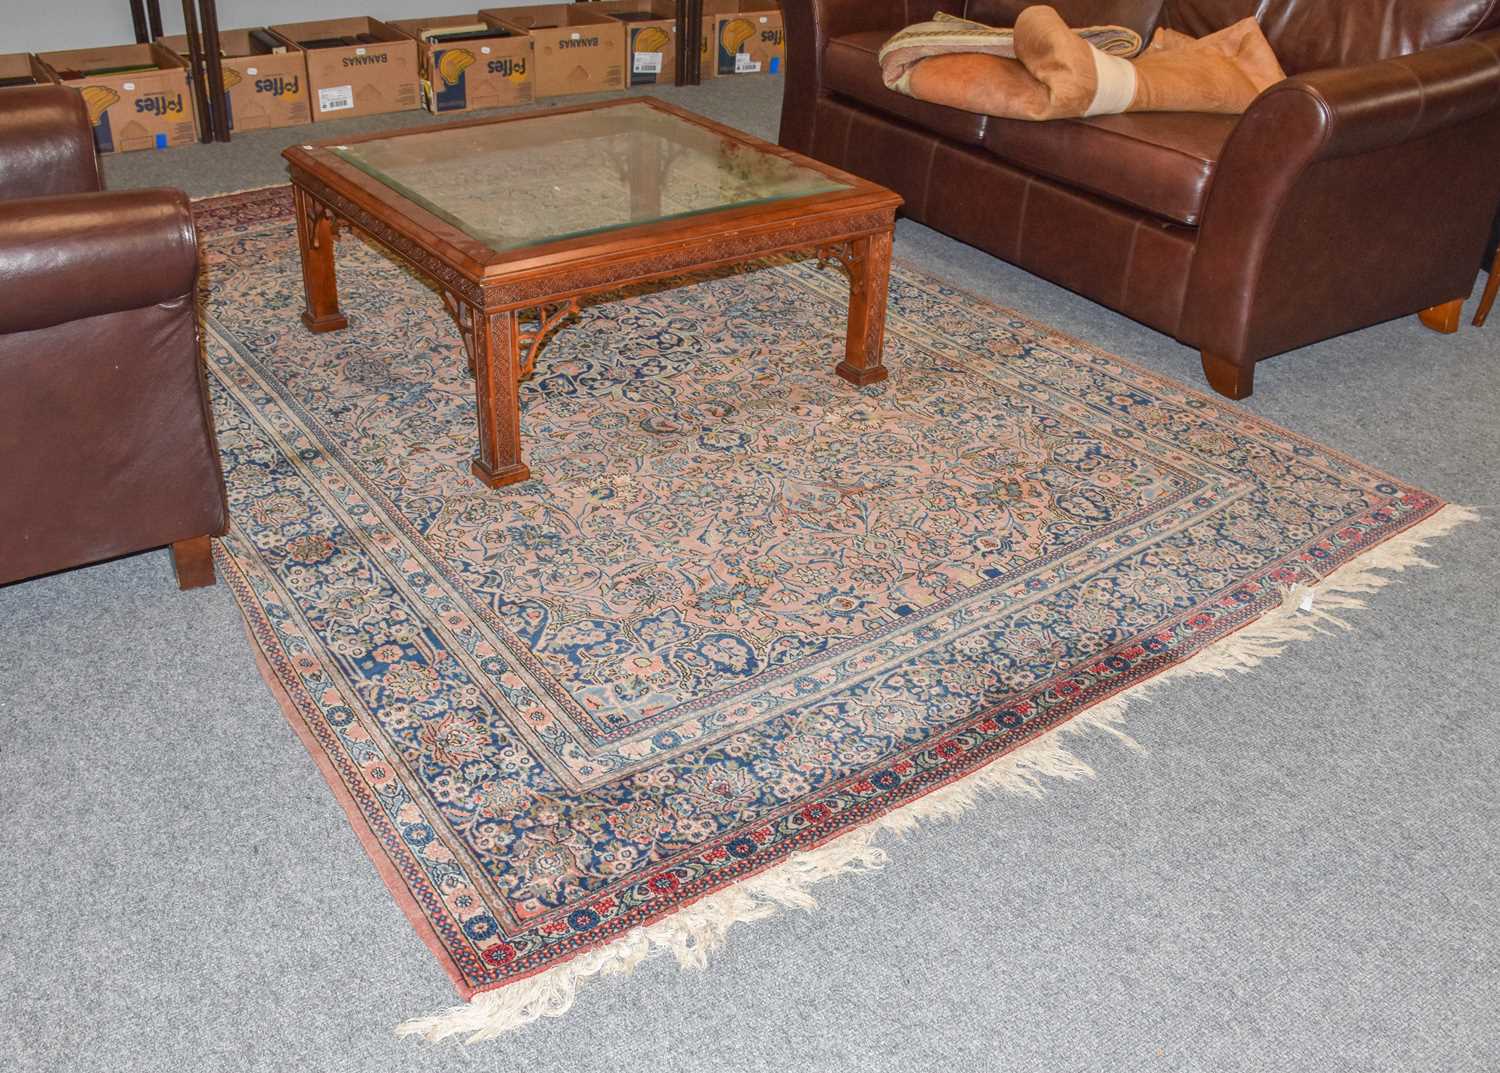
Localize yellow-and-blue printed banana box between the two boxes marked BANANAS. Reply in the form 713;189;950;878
392;14;534;114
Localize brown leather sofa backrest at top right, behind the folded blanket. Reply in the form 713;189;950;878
1163;0;1500;75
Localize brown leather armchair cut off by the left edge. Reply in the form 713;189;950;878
0;86;228;588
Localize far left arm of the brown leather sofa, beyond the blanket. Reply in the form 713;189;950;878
780;0;965;153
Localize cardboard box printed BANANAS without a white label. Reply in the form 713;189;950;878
480;3;626;98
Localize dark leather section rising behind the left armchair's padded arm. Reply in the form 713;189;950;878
0;86;102;198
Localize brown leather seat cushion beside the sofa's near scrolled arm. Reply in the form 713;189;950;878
984;113;1239;227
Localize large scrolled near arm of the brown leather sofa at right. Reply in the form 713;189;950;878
1178;33;1500;366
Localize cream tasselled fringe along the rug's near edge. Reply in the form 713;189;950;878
396;504;1479;1043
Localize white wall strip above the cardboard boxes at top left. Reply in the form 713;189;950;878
0;0;543;53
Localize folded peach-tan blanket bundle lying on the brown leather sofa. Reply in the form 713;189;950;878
879;5;1286;120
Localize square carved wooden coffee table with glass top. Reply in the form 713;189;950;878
284;98;902;488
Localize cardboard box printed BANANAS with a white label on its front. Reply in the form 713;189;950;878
270;17;422;122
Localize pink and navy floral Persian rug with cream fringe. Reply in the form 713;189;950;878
198;188;1469;1037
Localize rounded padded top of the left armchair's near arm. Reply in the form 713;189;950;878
0;191;198;333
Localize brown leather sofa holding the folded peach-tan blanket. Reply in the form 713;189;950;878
782;0;1500;398
